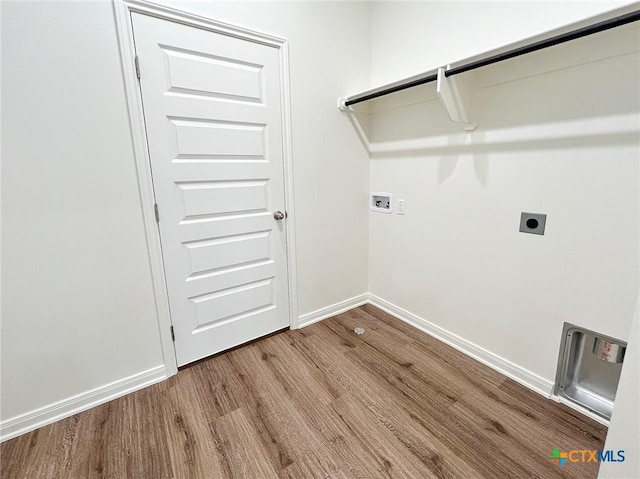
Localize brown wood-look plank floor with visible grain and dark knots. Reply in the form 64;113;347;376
0;306;606;479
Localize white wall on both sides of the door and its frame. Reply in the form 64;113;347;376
1;2;370;440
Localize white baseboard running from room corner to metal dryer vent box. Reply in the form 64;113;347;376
369;294;553;398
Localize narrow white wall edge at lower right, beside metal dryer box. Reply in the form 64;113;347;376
598;310;640;479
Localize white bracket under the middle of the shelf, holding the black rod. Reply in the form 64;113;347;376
436;65;478;130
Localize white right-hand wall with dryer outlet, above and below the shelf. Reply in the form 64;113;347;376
370;2;640;393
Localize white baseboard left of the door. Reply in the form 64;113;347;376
0;365;168;442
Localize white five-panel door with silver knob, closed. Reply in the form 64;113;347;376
132;13;289;366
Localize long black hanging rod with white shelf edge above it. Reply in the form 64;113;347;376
344;10;640;106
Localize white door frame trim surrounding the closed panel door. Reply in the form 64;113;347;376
113;0;298;376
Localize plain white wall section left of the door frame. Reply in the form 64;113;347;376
1;2;163;433
